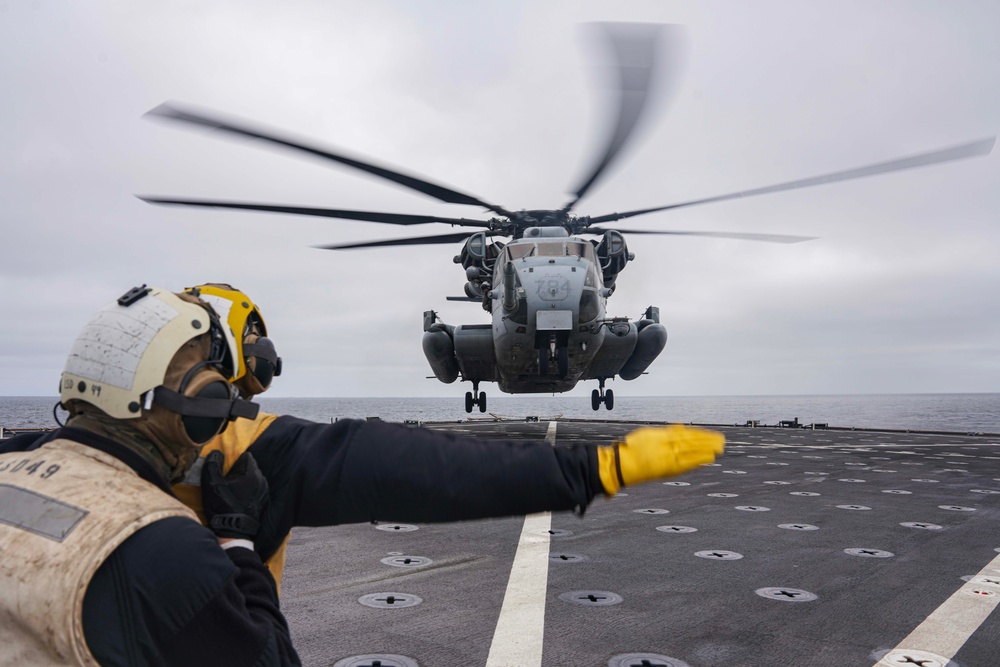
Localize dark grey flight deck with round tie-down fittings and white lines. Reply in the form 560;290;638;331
281;419;1000;667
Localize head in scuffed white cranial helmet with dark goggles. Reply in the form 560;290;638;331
59;285;258;471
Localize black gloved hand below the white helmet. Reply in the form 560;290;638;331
201;450;268;541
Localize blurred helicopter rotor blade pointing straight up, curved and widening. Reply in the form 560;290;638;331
562;23;683;213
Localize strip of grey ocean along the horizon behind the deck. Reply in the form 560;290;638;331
0;394;1000;433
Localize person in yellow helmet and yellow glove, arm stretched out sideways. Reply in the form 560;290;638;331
0;284;724;590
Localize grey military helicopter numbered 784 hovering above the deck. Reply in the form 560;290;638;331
140;24;995;412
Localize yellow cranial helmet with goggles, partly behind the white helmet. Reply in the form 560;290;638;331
185;283;281;398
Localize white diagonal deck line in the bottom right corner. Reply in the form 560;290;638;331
875;556;1000;667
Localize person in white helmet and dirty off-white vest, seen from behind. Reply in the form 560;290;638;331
0;286;299;665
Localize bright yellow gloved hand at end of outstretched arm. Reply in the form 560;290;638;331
597;424;726;496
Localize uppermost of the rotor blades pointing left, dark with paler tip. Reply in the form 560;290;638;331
145;102;510;215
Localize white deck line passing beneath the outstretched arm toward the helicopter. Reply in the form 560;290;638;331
486;421;556;667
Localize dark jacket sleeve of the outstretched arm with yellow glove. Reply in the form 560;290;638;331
249;416;604;559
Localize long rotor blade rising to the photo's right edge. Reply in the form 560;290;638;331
590;136;996;223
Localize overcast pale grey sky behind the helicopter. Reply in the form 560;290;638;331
0;0;1000;399
